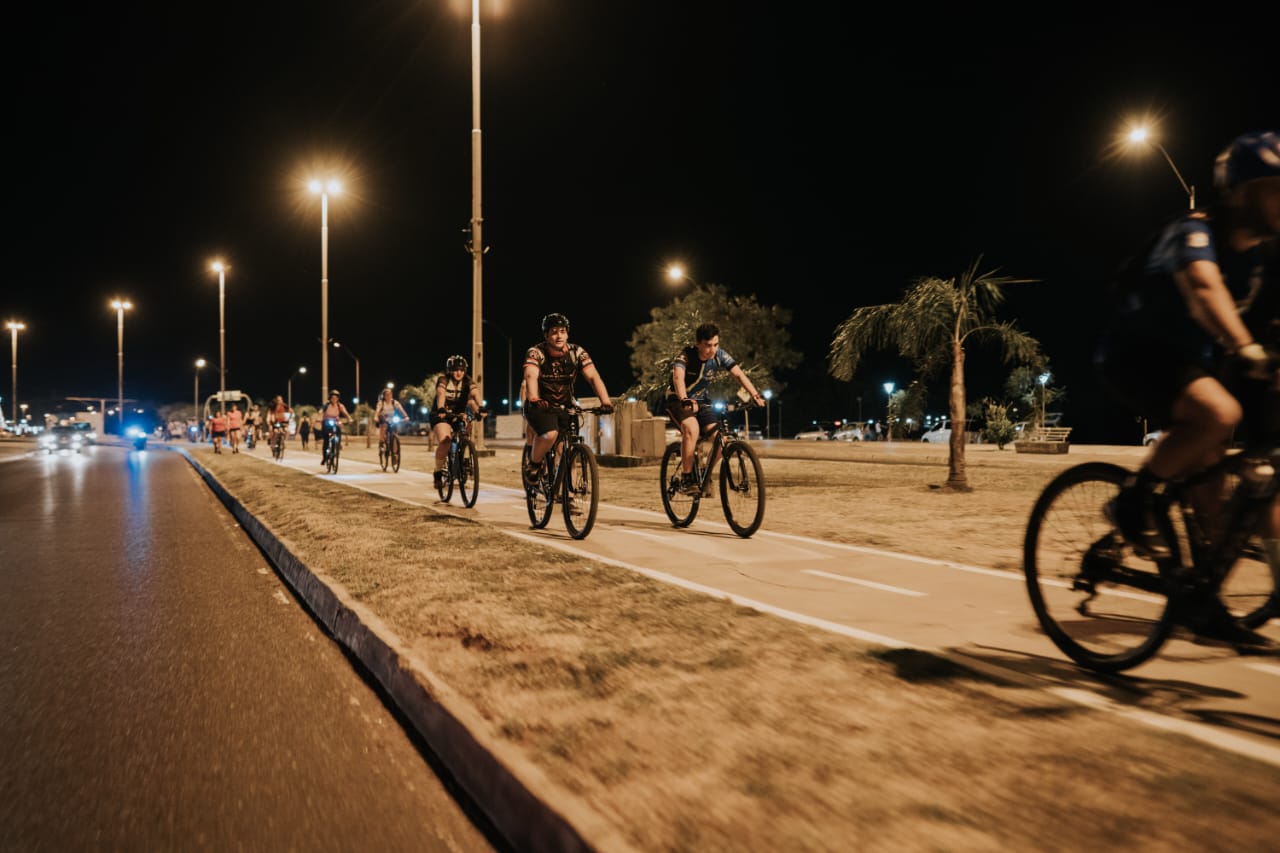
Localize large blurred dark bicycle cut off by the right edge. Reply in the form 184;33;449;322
1023;425;1280;672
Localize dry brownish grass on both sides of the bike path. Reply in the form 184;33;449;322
201;440;1280;850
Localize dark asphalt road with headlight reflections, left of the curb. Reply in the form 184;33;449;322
0;442;500;850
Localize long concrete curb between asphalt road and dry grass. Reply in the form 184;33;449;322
177;448;630;852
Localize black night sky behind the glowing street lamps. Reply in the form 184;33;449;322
10;6;1280;442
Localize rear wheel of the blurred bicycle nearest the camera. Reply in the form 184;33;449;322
1023;462;1178;672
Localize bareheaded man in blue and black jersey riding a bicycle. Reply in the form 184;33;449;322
664;323;764;494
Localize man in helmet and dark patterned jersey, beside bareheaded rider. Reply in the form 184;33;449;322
524;314;613;487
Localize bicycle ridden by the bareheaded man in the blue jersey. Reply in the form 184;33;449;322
659;399;764;539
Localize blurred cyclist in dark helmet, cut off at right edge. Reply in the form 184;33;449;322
1094;131;1280;646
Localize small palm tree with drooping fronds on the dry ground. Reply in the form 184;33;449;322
827;255;1041;491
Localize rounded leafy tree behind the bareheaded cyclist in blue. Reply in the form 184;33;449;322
627;284;803;409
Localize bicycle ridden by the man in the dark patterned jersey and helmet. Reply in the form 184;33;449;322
520;405;613;539
